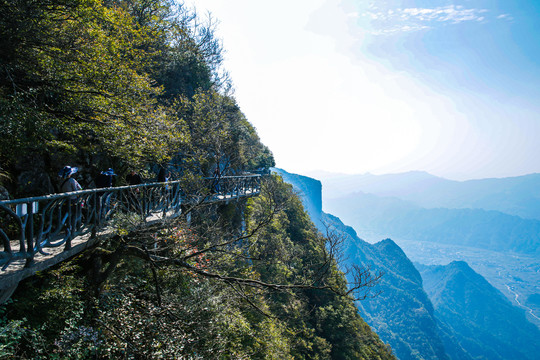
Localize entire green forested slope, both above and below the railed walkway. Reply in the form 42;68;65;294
0;0;394;359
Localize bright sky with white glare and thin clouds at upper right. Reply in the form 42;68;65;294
189;0;540;180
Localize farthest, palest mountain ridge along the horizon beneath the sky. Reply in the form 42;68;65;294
322;171;540;220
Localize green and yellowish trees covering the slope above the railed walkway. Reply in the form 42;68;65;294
0;0;274;194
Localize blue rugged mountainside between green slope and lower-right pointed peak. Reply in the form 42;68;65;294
324;215;450;360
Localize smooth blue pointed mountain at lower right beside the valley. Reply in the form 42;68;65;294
417;261;540;360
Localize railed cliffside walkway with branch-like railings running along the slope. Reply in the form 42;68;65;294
0;175;261;303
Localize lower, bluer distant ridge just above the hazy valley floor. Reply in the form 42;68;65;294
325;193;540;255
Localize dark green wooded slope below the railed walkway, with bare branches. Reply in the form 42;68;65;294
0;174;393;359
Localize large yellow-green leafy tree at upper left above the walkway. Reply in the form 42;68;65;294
0;0;187;191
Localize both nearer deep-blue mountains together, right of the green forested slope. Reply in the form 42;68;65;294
280;169;540;360
